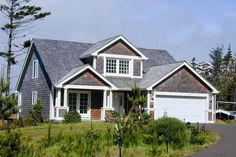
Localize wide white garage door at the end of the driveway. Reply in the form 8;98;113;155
155;95;207;123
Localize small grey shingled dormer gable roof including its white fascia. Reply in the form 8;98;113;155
80;35;148;60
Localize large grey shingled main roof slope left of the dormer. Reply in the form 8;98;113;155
33;39;92;84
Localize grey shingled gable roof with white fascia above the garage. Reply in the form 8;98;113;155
140;62;219;94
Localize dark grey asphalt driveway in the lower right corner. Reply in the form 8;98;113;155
192;124;236;157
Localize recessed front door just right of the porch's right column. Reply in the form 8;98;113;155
113;92;125;116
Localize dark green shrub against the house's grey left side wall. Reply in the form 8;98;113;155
29;100;44;125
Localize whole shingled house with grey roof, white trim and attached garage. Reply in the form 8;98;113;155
16;35;218;123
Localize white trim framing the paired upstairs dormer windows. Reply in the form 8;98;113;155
103;57;133;77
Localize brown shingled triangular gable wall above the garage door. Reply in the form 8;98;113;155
153;68;211;94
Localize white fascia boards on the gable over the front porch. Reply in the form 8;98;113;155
56;65;117;90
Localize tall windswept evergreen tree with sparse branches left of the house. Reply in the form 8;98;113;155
0;0;50;95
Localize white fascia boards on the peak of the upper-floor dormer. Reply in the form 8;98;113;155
91;36;148;60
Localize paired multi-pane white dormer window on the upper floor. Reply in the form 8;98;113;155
105;58;131;76
